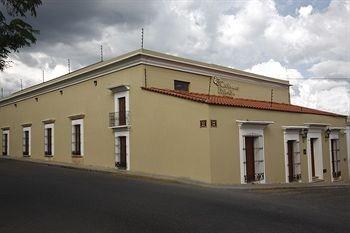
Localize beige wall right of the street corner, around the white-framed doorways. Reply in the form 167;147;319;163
210;106;349;183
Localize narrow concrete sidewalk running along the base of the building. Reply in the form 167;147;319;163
1;156;350;190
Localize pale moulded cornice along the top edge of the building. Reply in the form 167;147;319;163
0;49;290;107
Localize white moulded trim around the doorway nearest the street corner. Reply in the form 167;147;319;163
236;120;274;184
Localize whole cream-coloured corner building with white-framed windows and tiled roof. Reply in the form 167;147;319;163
0;50;349;184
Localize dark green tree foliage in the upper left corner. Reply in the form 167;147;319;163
0;0;42;71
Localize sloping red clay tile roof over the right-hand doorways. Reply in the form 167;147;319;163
142;87;345;117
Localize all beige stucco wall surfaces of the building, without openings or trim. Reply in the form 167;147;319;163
0;62;348;184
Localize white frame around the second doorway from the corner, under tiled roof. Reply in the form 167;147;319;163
284;129;301;183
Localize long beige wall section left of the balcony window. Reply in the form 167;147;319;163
0;66;143;167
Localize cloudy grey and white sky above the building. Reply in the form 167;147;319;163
0;0;350;114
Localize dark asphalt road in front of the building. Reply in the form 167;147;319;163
0;159;350;233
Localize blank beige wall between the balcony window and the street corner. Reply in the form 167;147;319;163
131;89;210;182
